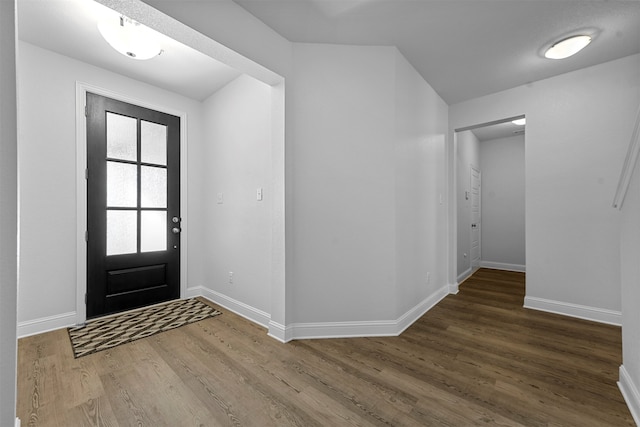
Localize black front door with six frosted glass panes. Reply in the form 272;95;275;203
87;93;180;318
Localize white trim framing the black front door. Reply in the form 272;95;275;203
76;81;189;325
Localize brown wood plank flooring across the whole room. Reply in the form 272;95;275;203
17;269;634;427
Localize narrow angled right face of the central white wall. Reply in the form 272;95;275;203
395;51;448;318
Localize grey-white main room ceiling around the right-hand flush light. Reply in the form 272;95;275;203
234;0;640;105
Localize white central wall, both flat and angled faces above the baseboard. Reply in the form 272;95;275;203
288;44;448;334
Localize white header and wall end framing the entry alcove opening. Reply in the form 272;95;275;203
140;0;295;332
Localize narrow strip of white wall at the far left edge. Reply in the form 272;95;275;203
0;1;18;426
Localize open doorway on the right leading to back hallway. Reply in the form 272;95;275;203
455;116;526;283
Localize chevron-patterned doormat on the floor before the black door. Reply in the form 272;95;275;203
67;298;222;359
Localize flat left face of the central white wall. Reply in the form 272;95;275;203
287;44;396;323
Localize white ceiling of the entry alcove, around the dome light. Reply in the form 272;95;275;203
18;0;240;101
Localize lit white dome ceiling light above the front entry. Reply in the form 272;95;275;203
98;16;162;60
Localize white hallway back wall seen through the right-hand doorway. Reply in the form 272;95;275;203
479;135;526;268
